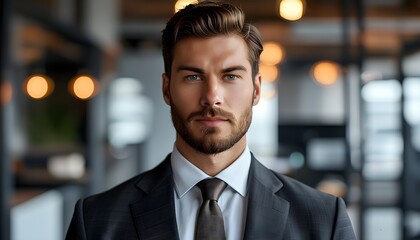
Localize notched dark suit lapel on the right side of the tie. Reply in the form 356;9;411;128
244;156;289;239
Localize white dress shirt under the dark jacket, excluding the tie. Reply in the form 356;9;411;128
171;147;251;240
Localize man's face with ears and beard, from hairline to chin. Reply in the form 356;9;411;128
163;35;261;154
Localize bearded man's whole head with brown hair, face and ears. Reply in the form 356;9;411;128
162;1;262;154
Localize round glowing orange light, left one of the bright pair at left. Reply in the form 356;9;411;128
25;75;54;99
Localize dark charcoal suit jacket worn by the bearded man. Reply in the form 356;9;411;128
66;156;356;240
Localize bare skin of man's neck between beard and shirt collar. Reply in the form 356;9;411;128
175;136;246;176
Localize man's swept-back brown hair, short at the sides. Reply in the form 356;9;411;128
161;1;263;78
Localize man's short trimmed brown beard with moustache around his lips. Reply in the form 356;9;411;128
171;101;253;154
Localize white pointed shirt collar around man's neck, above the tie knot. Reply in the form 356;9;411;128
171;146;251;198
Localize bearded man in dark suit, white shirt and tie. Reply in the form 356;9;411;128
67;1;355;240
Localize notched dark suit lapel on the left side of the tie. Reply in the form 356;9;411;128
130;157;179;240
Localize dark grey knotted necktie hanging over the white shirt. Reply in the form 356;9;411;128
195;178;226;240
